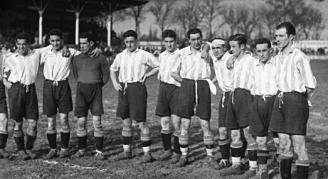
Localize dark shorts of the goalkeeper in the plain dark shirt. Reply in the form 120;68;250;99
74;82;104;117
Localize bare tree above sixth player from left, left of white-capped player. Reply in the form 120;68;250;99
174;0;204;36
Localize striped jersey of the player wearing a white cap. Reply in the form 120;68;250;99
212;52;233;92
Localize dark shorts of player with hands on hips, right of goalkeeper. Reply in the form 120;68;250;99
116;82;147;122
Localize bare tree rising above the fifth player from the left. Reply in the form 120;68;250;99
148;0;176;32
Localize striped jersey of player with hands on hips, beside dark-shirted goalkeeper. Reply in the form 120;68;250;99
110;49;159;83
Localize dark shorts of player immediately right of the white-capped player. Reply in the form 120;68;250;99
227;88;253;129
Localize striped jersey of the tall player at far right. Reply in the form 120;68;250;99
275;48;317;93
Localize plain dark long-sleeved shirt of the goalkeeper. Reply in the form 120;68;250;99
72;53;109;85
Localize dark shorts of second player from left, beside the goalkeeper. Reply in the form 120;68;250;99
43;80;73;117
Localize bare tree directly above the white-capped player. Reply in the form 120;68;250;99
200;0;224;39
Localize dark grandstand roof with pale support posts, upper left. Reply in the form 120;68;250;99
0;0;149;44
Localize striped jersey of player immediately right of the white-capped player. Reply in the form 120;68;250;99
233;53;256;91
